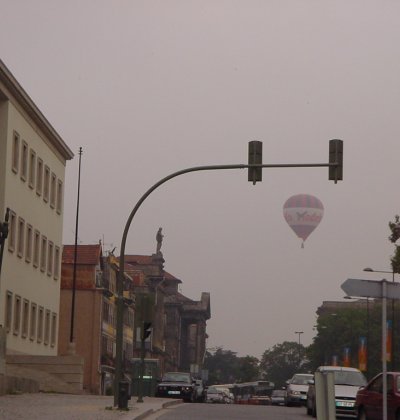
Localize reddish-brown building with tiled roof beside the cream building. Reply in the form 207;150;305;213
59;244;134;394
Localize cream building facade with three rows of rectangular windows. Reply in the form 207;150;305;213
0;60;73;355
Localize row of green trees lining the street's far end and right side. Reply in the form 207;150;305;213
204;215;400;388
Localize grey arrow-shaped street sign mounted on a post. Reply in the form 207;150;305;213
341;279;400;299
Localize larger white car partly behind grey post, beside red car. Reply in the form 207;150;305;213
307;366;367;418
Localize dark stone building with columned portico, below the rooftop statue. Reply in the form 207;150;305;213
125;252;211;376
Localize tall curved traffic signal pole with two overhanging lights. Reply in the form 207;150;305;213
114;140;343;408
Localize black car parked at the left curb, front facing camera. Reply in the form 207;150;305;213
156;372;195;402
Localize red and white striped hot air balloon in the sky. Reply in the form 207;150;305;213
283;194;324;248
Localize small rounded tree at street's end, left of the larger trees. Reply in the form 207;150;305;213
260;341;305;388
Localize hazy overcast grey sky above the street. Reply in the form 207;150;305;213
0;0;400;357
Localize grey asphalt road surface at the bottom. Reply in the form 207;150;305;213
147;404;311;420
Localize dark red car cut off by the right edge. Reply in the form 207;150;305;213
356;372;400;420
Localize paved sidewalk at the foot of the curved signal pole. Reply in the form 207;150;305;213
0;393;182;420
